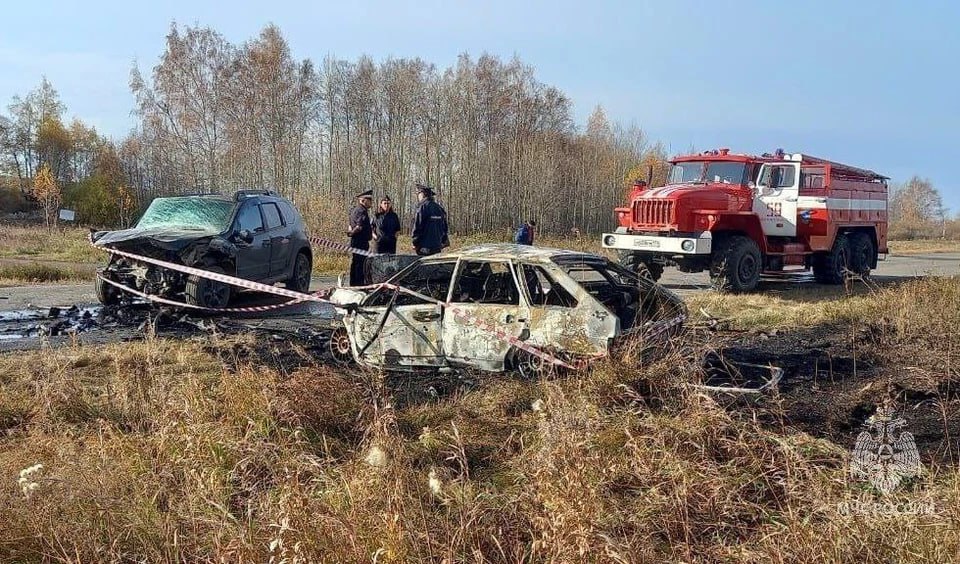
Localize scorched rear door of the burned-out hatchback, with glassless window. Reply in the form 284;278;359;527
441;260;530;371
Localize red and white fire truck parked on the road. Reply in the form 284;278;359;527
603;149;888;292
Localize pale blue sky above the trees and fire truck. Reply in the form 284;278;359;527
0;0;960;211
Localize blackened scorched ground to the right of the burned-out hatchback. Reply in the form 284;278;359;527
704;325;960;464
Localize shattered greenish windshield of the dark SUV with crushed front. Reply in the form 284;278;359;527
136;196;233;233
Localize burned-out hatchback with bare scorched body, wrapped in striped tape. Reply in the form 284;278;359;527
331;244;686;372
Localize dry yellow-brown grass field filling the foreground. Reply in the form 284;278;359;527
0;279;960;562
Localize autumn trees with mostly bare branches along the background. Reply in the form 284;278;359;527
0;20;947;236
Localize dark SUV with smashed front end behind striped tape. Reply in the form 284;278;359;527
92;190;313;308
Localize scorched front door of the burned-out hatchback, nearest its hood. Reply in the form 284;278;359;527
346;260;456;370
